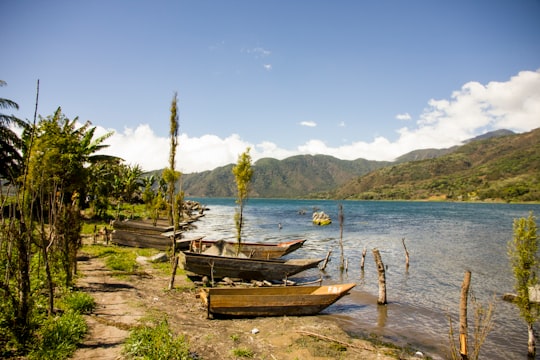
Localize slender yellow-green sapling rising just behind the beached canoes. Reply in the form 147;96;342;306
232;147;253;249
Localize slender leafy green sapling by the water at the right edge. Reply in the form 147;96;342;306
508;212;539;358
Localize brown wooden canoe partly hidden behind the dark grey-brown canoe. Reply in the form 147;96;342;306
191;239;306;259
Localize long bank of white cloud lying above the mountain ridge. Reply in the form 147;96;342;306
96;70;540;173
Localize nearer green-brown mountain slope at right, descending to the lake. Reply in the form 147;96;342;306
334;128;540;201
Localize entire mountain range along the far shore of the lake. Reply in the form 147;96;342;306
146;129;540;201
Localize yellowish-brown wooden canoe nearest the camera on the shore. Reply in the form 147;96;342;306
201;284;356;317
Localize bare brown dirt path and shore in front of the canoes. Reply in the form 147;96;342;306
73;250;405;360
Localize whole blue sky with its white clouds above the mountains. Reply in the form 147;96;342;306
0;0;540;173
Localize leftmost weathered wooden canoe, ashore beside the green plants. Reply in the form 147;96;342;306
111;229;198;250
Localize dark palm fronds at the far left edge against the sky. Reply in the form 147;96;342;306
0;80;28;181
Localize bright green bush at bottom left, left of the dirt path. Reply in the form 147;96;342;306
28;311;88;360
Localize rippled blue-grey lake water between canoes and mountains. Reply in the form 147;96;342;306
186;198;540;359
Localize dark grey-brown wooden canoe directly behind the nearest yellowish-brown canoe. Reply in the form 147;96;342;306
179;251;323;281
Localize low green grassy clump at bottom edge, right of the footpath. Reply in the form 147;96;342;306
124;320;192;360
